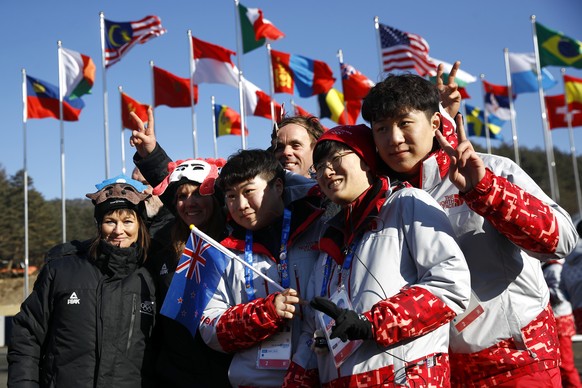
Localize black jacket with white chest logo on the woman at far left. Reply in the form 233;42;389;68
8;242;156;388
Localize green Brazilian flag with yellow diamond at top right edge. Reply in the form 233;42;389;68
536;22;582;69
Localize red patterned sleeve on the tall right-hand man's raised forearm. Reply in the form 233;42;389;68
463;169;560;253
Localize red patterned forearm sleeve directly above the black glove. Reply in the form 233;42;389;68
364;287;456;346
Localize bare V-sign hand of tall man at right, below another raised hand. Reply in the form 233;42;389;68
435;115;485;193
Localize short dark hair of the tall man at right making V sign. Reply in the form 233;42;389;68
362;73;440;124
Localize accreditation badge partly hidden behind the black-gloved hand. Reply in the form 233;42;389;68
317;287;363;368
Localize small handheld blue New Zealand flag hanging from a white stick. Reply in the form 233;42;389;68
160;233;229;336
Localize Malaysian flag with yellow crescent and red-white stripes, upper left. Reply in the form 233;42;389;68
103;15;166;67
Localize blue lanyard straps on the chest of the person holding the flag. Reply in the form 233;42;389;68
245;209;291;301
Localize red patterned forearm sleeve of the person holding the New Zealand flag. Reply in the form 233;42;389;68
216;293;285;353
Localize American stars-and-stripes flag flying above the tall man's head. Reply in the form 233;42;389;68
378;23;437;76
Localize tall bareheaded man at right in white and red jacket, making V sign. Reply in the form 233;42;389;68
362;68;578;387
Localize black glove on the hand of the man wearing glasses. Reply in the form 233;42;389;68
309;296;374;342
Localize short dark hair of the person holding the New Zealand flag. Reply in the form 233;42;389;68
217;149;285;191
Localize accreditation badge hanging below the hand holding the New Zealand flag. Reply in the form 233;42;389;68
257;324;292;369
